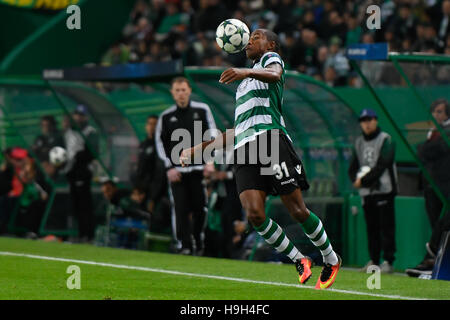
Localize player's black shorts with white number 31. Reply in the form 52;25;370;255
234;130;309;195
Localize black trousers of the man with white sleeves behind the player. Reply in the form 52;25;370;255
170;170;207;250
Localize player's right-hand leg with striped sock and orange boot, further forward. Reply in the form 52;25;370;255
281;189;342;289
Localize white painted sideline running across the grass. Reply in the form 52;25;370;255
0;251;428;300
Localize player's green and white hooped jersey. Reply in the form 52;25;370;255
234;52;290;149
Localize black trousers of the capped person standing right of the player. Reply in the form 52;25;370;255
363;194;396;264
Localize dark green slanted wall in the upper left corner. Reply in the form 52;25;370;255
0;0;135;75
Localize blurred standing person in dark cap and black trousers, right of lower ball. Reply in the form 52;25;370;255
64;105;99;242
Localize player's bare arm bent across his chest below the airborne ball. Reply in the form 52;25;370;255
219;63;283;84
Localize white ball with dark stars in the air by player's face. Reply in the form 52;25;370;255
216;19;250;53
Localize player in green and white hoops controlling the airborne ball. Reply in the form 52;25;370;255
180;29;341;289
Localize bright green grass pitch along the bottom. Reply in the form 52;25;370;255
0;238;450;300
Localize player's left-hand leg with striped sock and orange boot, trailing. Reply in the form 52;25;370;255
239;190;311;284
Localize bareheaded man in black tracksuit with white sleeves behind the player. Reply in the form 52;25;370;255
155;77;216;254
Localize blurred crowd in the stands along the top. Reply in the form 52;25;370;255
101;0;450;86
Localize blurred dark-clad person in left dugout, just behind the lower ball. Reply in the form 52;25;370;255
31;115;65;178
